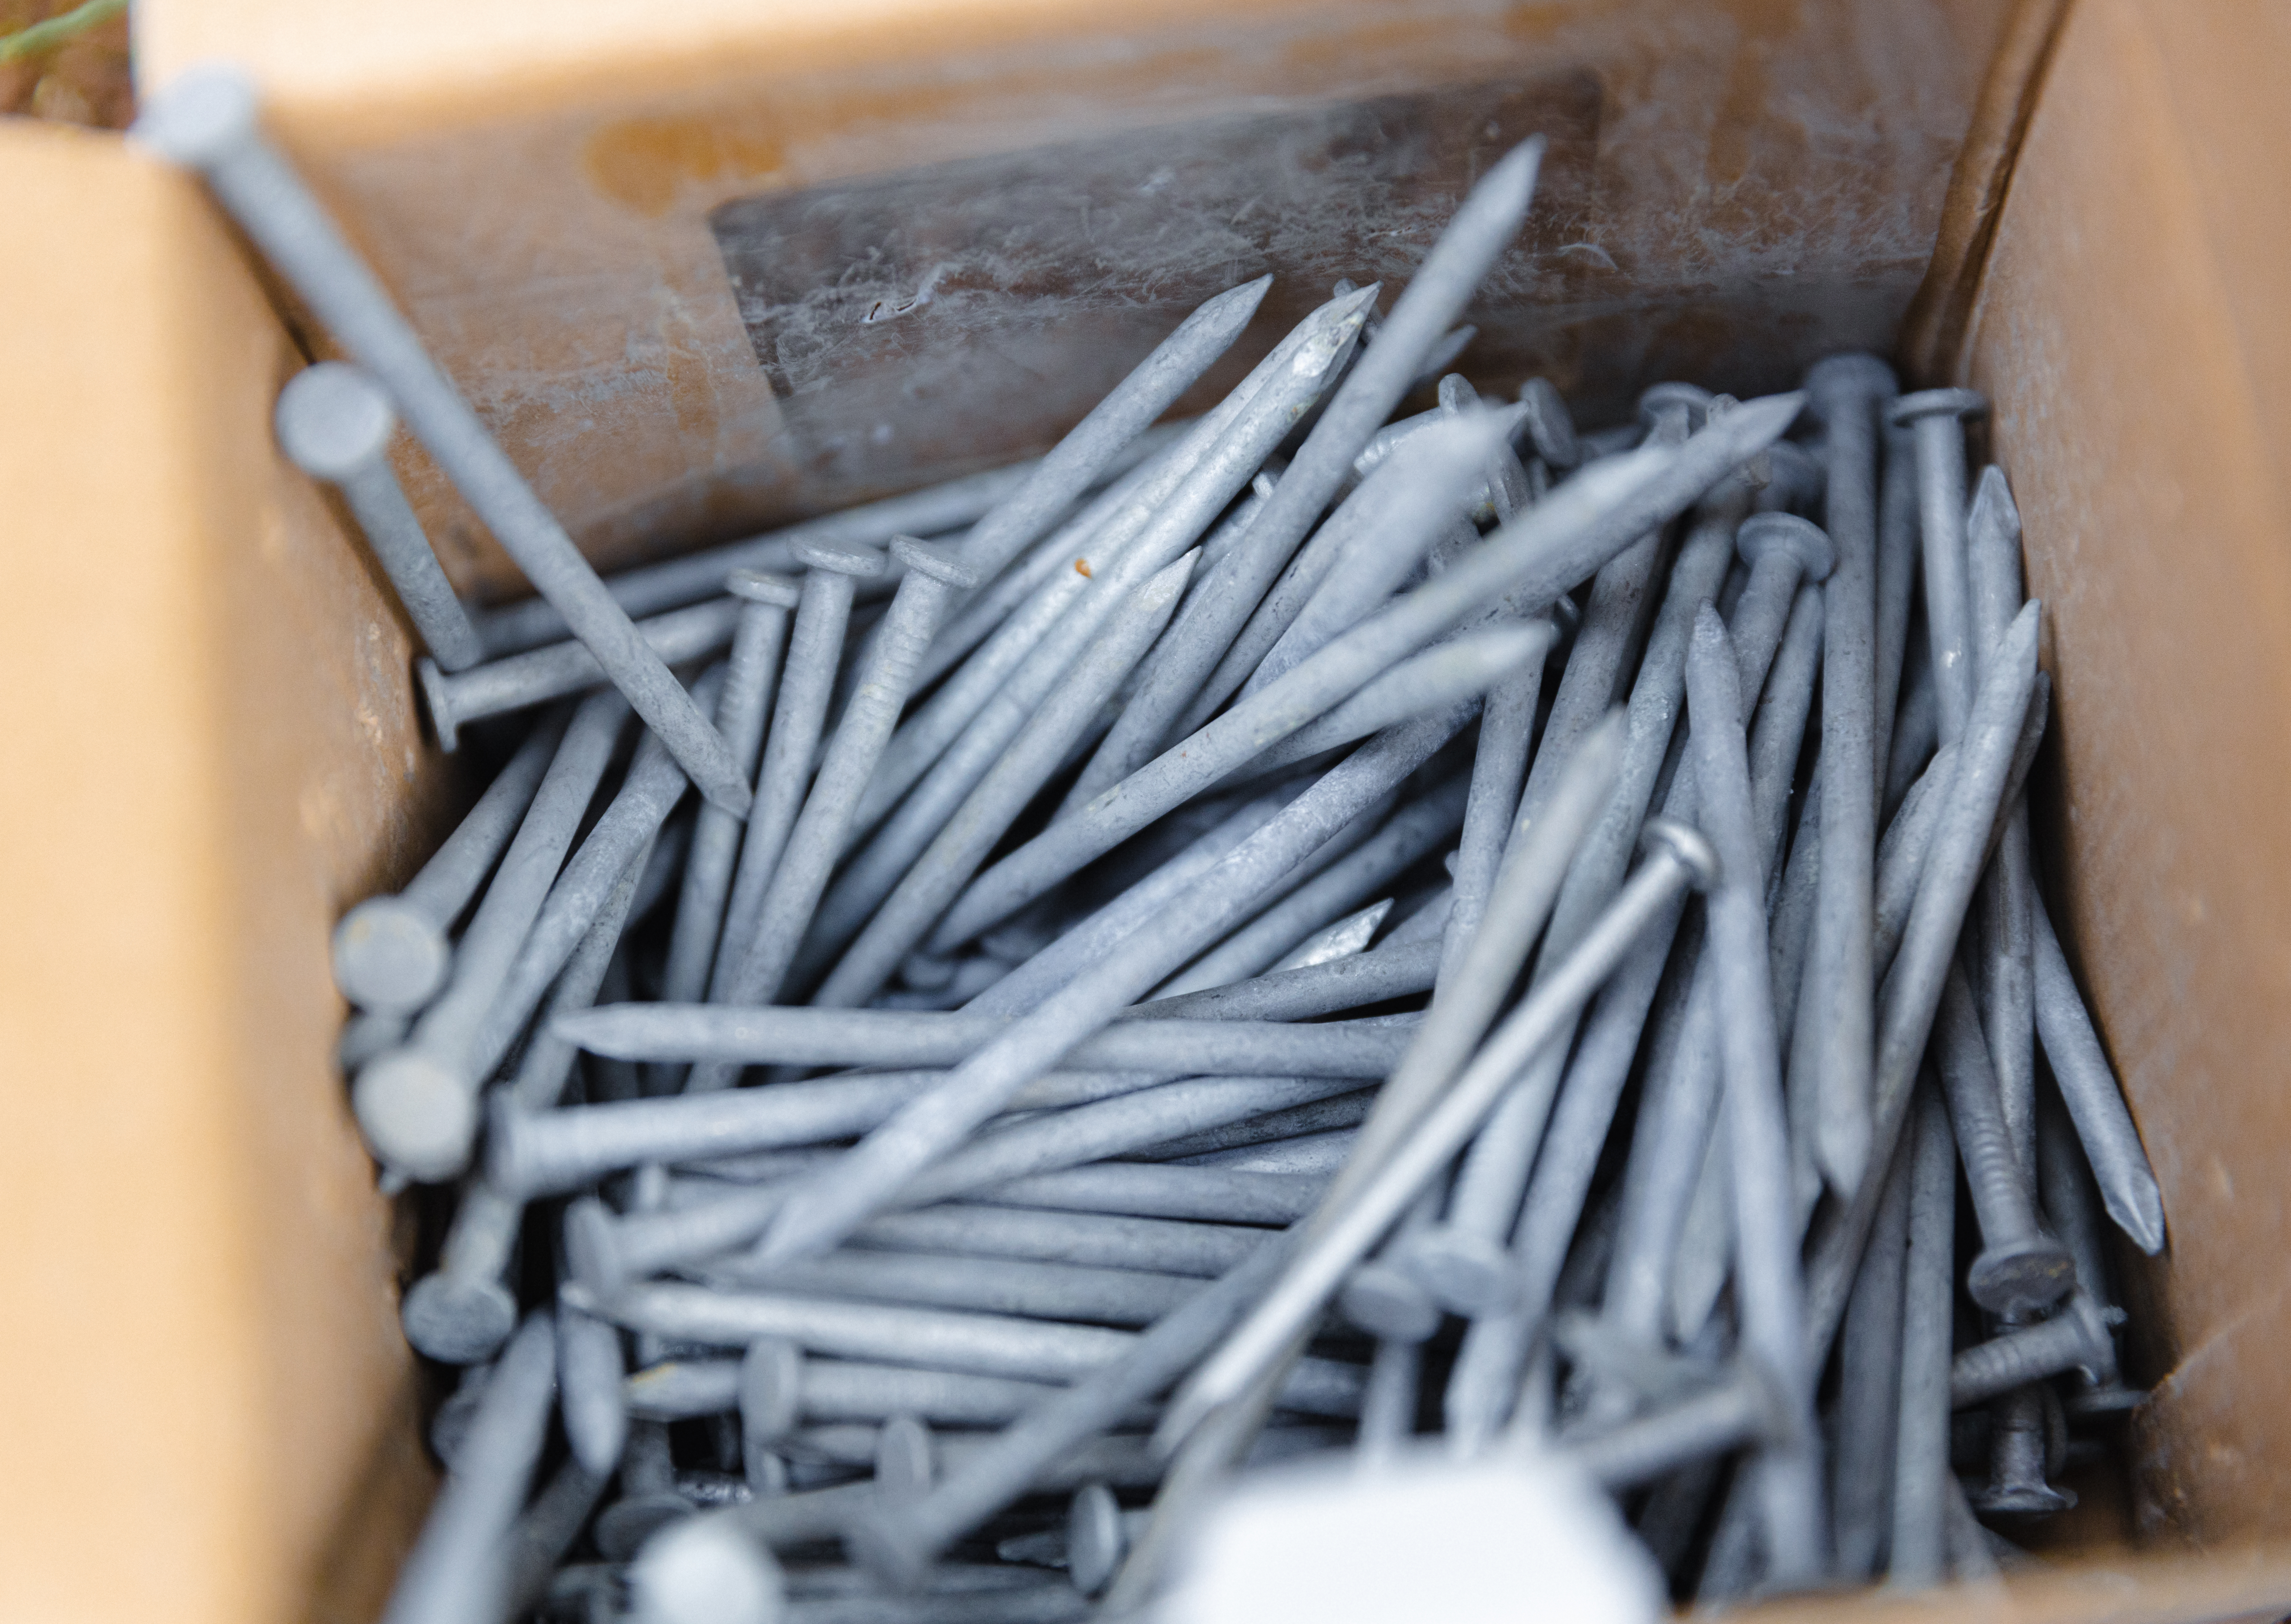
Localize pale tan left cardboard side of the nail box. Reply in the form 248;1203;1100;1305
0;124;442;1624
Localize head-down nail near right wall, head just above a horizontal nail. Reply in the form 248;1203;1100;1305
1933;967;2076;1315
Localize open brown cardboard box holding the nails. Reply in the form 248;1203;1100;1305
0;0;2291;1622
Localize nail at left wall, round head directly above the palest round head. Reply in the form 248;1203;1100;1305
332;715;568;1015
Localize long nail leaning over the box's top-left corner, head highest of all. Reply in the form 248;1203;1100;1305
135;64;749;815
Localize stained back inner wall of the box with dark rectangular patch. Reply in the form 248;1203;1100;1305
137;0;2014;593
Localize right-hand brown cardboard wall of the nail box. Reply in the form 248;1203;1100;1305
1966;0;2291;1557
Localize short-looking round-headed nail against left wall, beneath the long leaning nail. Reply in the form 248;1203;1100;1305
275;362;486;671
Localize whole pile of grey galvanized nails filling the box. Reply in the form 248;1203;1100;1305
140;57;2163;1624
